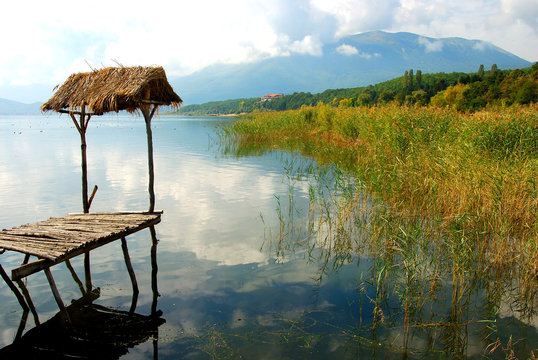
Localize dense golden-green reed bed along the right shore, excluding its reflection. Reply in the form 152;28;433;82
226;104;538;303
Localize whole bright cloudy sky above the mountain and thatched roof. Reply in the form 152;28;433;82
0;0;538;102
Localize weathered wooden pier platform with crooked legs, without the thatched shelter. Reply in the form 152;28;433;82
0;211;162;328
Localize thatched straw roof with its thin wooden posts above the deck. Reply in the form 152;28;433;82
41;66;183;213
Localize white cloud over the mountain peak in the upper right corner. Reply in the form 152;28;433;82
311;0;538;61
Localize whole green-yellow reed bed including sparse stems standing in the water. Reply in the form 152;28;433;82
219;104;538;358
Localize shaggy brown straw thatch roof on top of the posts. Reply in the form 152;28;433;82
41;66;182;114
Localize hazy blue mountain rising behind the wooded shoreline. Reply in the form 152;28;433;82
169;31;531;104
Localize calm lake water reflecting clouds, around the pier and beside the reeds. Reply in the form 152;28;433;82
0;115;538;359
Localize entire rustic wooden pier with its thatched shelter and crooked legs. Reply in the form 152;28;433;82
0;66;183;346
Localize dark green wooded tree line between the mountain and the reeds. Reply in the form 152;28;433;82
180;62;538;115
